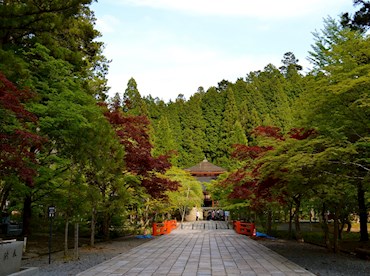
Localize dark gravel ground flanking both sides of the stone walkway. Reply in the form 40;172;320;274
22;237;370;276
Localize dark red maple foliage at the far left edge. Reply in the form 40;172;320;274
0;72;45;186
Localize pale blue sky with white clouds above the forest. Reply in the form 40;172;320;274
92;0;356;102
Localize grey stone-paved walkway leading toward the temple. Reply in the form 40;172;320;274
78;221;314;276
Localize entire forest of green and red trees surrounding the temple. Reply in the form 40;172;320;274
0;0;370;254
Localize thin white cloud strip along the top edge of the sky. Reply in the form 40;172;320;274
119;0;348;19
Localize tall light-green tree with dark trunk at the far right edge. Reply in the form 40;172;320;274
301;18;370;241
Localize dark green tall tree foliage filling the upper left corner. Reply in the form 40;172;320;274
0;0;108;100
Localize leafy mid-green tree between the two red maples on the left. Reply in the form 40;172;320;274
0;43;111;235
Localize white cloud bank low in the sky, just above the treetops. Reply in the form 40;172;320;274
108;46;279;101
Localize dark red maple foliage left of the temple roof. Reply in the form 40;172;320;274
105;102;178;197
